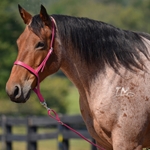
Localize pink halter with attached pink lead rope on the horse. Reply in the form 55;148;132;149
14;17;105;150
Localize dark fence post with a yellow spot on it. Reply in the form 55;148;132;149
58;124;69;150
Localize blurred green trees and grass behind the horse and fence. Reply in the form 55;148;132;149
0;0;150;150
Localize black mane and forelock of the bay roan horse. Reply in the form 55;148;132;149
31;15;150;71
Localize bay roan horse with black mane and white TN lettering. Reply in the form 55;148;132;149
6;6;150;150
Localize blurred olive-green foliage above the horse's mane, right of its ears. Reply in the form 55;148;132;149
48;0;150;32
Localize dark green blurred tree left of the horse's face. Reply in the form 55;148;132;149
0;0;23;97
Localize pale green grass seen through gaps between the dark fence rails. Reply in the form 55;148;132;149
0;126;90;150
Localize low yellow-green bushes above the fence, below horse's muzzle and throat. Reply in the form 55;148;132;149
0;76;72;116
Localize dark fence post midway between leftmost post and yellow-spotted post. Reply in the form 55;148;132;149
27;118;37;150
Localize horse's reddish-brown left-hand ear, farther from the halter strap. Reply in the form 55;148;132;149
18;5;32;25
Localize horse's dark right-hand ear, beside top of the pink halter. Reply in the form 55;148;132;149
40;5;51;27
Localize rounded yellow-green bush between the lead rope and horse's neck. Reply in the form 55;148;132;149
41;76;71;113
